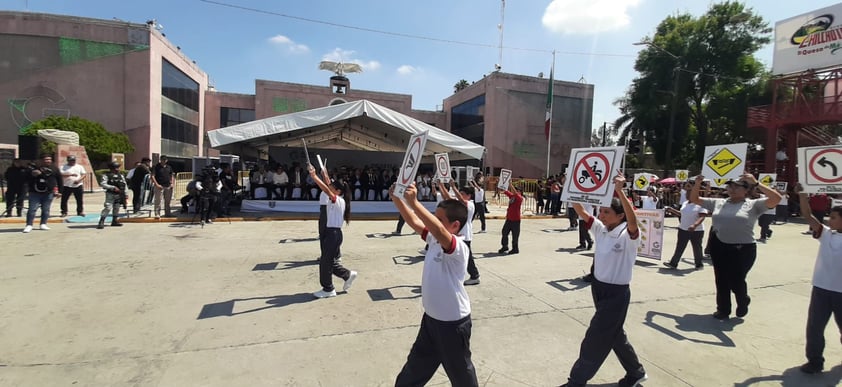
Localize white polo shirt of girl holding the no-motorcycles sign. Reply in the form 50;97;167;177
585;216;640;285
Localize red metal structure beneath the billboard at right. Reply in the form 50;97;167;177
748;67;842;185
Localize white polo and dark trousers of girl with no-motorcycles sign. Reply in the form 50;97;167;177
568;217;646;386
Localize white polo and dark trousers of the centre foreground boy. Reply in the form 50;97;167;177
395;230;478;387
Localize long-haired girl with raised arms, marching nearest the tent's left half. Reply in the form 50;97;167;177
307;163;357;298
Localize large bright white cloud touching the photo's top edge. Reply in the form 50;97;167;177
541;0;641;35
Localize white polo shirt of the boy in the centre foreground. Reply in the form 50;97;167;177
421;229;471;321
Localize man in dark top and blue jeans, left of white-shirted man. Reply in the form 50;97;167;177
23;154;61;233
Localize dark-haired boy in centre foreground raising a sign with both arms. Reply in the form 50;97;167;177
390;184;478;386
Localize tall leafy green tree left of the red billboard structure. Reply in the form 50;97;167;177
615;1;771;171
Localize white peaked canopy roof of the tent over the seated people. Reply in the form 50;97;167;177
208;100;485;160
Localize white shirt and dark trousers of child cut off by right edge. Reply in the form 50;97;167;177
806;225;842;370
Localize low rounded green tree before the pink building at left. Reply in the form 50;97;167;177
21;116;134;168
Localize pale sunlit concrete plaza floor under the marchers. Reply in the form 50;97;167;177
0;197;842;386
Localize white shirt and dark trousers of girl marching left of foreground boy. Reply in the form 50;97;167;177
319;196;351;292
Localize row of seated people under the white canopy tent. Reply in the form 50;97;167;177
248;163;442;201
